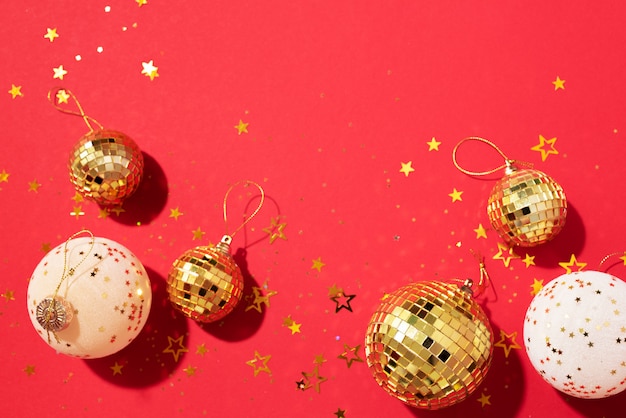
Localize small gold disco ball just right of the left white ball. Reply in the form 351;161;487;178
167;235;243;322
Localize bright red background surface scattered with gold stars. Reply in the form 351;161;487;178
0;0;626;417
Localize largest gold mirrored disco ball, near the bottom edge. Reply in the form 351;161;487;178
365;281;493;409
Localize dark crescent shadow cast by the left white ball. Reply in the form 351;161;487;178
84;267;188;388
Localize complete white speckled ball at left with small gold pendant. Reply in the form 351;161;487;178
27;237;152;358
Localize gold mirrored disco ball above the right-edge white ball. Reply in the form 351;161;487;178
487;167;567;247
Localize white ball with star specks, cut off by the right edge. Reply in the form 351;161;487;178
524;271;626;398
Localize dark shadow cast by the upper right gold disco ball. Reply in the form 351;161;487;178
519;202;586;267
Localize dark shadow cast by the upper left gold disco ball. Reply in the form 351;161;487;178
109;152;169;225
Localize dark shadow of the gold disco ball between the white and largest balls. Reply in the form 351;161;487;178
200;248;267;342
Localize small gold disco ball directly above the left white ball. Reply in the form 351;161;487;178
69;130;144;206
